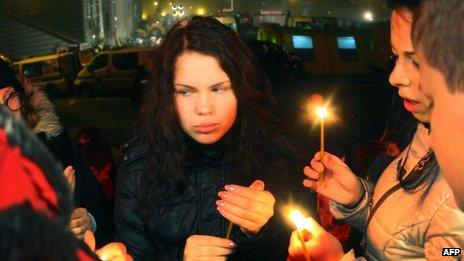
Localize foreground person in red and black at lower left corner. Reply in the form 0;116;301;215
0;104;132;261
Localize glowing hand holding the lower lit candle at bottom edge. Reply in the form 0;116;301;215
287;219;344;261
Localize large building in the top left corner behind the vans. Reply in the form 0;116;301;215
0;0;141;59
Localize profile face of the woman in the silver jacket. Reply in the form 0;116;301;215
389;10;432;122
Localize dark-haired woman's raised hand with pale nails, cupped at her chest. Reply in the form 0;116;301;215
216;180;275;234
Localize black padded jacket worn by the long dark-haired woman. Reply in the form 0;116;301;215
114;136;315;260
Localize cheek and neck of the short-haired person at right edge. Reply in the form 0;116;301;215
417;48;464;210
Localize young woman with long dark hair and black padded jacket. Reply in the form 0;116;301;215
114;17;314;260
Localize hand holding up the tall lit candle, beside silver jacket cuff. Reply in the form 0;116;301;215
303;152;364;206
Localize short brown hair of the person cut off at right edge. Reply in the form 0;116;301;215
412;0;464;93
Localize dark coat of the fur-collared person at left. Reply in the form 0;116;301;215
37;131;112;247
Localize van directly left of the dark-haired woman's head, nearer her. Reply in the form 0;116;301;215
74;48;156;97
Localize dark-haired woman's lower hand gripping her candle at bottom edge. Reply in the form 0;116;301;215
184;235;235;261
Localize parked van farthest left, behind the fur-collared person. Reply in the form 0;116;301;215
13;52;80;97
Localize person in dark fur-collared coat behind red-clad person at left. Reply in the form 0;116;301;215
0;59;109;246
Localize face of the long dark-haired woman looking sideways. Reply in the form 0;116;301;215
174;52;237;144
